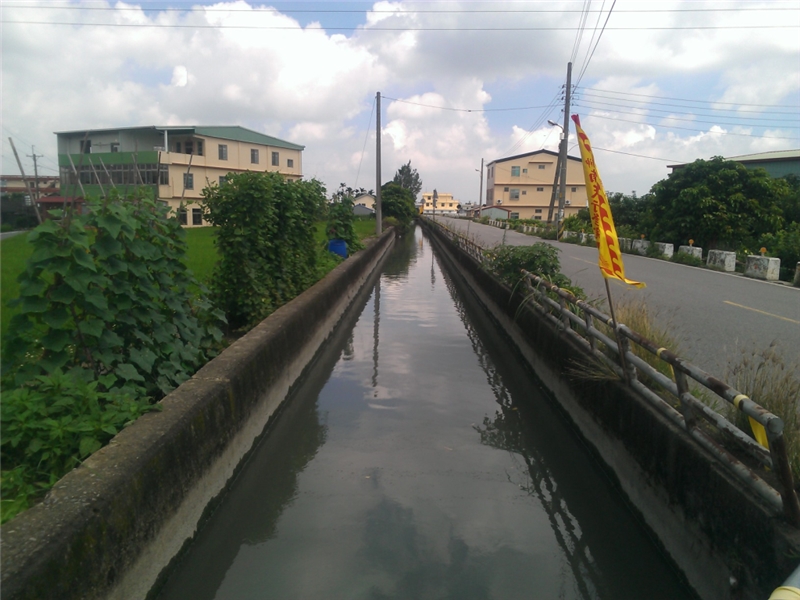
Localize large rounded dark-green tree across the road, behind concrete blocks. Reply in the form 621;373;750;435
650;157;788;249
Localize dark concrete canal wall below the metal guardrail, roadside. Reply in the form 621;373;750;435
426;220;800;600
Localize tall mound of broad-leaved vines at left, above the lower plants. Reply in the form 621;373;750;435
3;194;222;397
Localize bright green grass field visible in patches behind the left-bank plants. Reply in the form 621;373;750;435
0;219;382;337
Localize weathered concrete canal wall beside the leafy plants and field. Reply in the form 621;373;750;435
0;230;395;600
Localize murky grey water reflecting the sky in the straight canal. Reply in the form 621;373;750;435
159;229;694;600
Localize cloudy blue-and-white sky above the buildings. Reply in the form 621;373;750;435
0;0;800;202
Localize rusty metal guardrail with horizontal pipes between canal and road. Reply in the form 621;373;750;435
427;219;800;527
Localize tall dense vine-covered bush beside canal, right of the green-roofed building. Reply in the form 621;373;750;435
203;172;328;330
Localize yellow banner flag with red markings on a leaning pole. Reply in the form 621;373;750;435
572;115;644;288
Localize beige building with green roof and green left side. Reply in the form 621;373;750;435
56;126;304;227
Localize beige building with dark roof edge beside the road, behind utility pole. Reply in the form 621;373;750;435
486;150;589;221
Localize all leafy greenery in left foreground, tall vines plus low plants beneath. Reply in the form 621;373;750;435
0;194;223;519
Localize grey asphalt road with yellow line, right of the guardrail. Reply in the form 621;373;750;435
437;217;800;377
